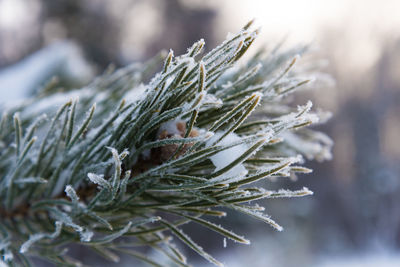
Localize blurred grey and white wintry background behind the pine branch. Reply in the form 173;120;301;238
0;0;400;267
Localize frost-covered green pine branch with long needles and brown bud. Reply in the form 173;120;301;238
0;23;332;266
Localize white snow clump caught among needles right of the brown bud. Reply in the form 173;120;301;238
206;132;248;177
